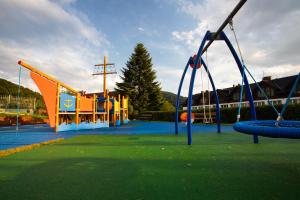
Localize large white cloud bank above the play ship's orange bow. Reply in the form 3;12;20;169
0;0;112;94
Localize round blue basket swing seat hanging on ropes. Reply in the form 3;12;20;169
233;120;300;139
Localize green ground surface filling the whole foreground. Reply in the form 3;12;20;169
0;133;300;200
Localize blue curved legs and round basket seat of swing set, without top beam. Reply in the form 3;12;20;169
175;31;300;145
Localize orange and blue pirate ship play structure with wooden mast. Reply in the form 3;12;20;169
18;57;128;132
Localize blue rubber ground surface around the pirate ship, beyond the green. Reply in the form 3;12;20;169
0;121;234;150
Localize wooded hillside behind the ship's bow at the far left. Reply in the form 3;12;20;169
0;78;42;99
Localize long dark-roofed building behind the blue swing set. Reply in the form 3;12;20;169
183;75;300;110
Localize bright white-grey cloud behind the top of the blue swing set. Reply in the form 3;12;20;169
172;0;300;92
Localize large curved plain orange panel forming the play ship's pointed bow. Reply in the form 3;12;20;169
30;72;57;127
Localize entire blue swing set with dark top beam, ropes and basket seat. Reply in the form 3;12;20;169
175;0;300;145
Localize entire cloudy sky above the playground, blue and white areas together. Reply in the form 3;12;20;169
0;0;300;96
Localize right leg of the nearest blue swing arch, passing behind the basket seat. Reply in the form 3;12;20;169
220;31;258;144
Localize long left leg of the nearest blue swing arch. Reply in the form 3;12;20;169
187;31;210;145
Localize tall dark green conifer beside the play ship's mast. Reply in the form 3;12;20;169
115;43;163;113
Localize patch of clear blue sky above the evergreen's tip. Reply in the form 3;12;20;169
72;0;197;68
